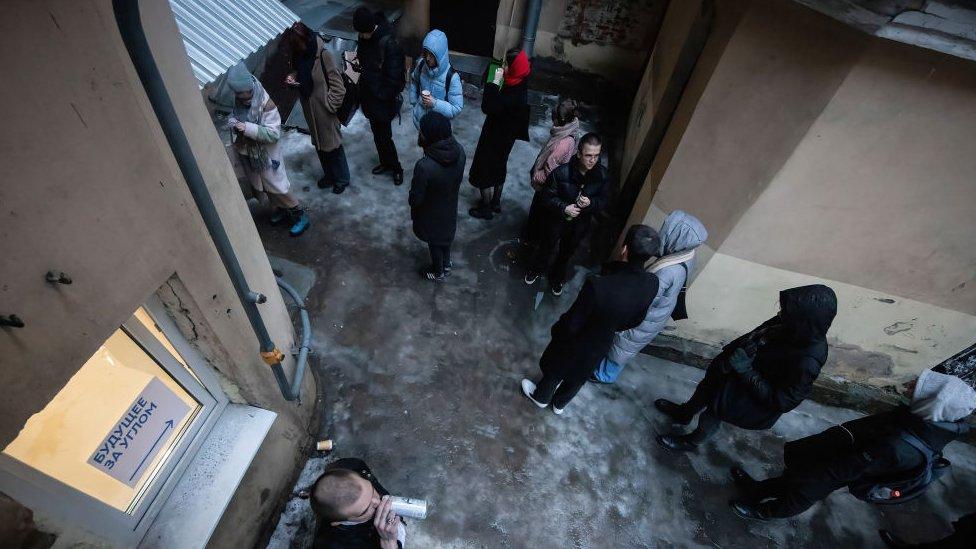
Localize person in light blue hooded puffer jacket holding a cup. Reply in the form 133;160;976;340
409;29;464;129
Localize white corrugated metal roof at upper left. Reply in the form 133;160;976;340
169;0;298;86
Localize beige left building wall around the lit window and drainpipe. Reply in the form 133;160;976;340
0;0;315;546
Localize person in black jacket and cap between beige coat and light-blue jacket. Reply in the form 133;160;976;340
352;7;406;185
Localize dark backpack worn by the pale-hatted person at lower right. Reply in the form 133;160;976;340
848;431;952;505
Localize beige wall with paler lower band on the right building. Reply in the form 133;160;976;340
630;0;976;394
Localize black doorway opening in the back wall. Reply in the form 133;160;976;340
430;0;498;57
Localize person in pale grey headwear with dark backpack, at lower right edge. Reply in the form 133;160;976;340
732;370;976;520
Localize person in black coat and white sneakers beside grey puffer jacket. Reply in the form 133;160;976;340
522;225;661;415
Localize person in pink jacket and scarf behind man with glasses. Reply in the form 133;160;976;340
520;99;579;244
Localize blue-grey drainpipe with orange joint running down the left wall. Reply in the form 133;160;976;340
112;0;311;401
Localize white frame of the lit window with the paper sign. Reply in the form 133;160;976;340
0;295;228;545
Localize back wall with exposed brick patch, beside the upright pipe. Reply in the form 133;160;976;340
494;0;668;83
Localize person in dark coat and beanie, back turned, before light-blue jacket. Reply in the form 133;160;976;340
409;111;465;282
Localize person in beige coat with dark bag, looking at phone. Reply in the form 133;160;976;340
285;23;349;194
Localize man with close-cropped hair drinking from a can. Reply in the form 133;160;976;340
309;458;407;549
